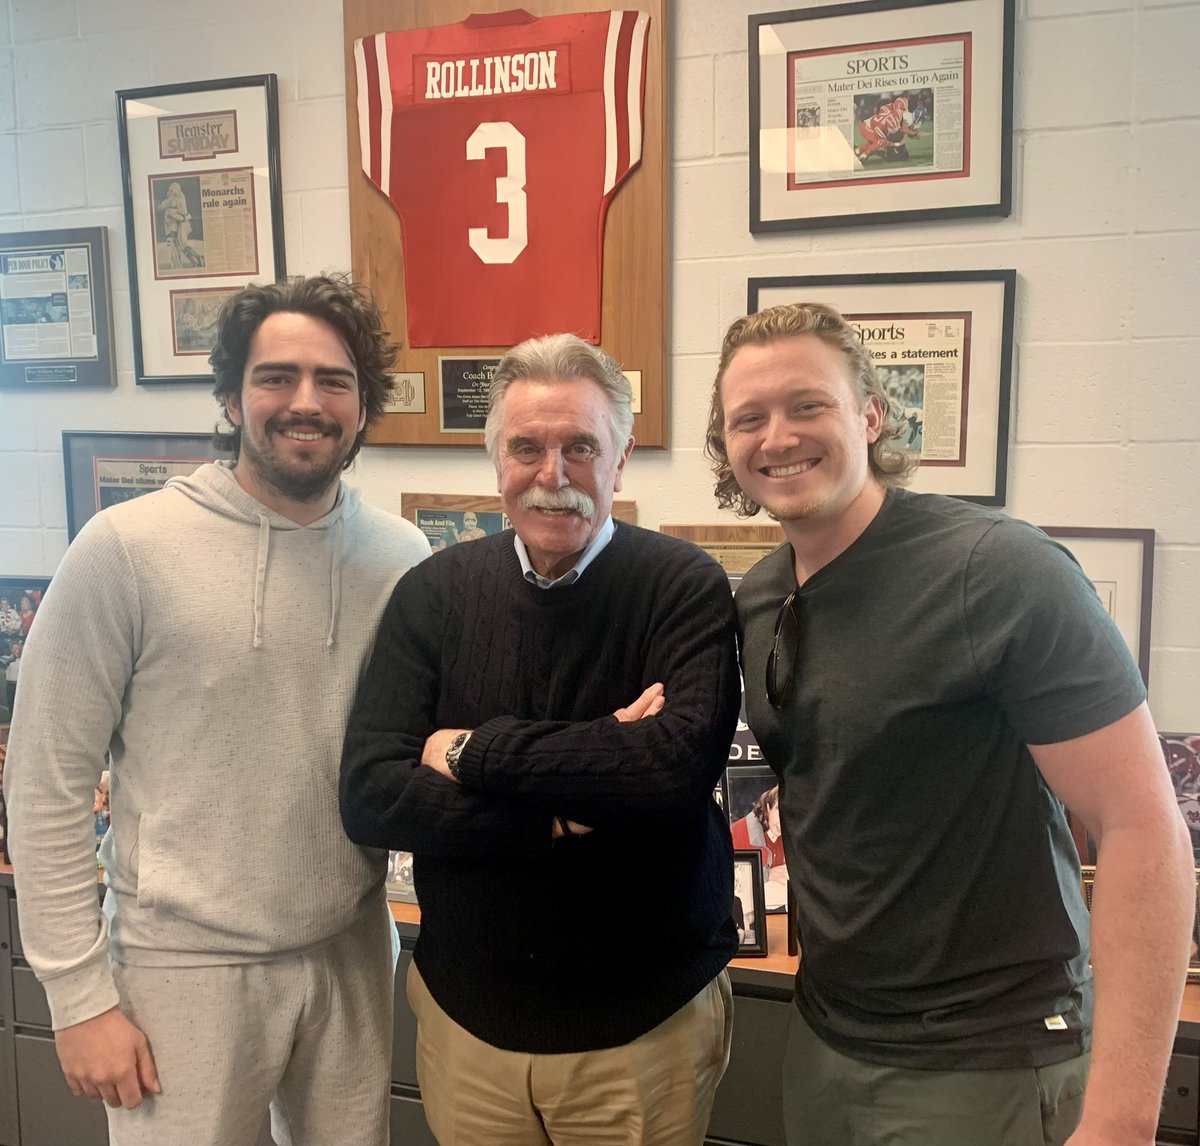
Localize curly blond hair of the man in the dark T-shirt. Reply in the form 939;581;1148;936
704;302;920;517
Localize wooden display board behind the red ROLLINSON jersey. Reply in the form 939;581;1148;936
343;0;670;446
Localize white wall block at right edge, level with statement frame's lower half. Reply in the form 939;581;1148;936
1128;338;1200;444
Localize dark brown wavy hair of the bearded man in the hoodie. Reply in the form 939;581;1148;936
209;275;396;469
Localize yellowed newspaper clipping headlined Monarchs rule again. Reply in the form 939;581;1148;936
150;167;258;278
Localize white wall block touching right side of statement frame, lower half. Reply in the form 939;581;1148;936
1016;342;1130;443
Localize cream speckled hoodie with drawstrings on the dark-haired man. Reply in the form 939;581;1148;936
5;464;428;1028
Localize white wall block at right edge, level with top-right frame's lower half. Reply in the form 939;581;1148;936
1133;120;1200;230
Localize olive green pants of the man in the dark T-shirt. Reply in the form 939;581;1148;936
784;1006;1091;1146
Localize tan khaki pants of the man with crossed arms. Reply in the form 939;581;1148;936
408;964;733;1146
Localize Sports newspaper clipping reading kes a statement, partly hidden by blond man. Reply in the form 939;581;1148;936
846;312;971;466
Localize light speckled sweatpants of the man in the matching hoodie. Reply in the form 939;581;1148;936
108;906;395;1146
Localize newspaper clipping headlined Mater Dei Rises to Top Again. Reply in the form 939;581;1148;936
787;34;971;191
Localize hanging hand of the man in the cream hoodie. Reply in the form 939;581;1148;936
54;1007;162;1110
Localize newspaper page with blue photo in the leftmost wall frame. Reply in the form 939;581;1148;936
0;246;98;362
